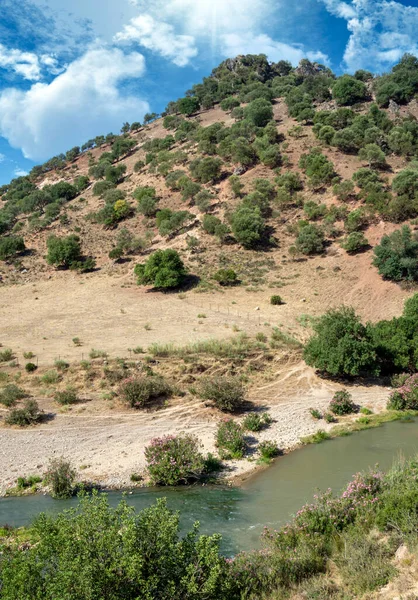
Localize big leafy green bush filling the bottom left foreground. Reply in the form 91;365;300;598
0;493;230;600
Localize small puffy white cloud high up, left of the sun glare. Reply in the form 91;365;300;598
114;15;198;67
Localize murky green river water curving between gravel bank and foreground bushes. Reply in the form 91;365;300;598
0;421;418;554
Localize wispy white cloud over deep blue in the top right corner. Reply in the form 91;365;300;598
321;0;418;71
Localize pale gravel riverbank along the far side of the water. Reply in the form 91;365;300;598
0;364;390;495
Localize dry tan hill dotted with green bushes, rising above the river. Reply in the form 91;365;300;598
0;51;418;485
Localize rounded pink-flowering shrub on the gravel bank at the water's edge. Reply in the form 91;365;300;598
145;434;205;485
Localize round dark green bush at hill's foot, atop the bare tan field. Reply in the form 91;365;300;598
135;249;186;289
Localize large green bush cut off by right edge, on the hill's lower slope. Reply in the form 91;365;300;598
373;225;418;281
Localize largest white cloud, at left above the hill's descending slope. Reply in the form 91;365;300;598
0;48;149;160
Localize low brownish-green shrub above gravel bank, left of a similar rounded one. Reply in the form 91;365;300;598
119;375;173;408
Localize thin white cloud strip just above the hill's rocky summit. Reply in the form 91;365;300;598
221;33;329;65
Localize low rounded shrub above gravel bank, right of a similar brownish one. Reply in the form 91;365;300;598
199;376;245;412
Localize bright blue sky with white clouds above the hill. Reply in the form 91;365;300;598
0;0;418;184
